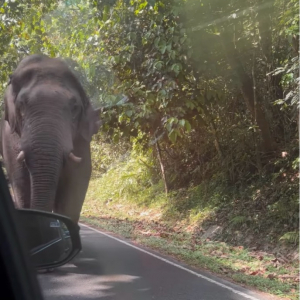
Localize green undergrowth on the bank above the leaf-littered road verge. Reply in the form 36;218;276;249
85;154;299;250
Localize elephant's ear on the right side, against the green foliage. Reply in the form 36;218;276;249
79;104;101;142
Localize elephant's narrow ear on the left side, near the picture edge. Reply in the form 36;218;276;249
4;82;20;135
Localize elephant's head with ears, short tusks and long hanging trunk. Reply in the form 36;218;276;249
4;55;100;211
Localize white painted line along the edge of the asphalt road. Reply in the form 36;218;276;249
79;223;261;300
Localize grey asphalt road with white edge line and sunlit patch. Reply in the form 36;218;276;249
39;226;270;300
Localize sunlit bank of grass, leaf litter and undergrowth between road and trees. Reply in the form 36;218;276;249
82;153;299;299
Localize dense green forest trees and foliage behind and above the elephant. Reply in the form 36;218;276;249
0;0;299;234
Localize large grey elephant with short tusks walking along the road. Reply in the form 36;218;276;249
0;54;101;223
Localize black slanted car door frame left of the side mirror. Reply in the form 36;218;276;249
0;165;43;300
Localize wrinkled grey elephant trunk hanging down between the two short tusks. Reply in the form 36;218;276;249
18;110;73;211
